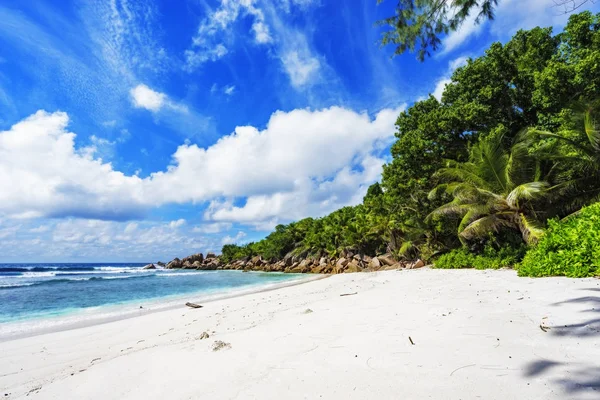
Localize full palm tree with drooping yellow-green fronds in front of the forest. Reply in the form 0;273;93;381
428;135;549;243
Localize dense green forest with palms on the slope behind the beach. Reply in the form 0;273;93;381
221;12;600;276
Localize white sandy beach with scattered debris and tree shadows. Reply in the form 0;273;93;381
0;269;600;400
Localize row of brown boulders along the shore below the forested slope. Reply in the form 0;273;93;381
165;251;425;274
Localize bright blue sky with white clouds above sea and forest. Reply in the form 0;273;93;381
0;0;600;262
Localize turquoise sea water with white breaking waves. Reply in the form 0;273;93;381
0;264;298;323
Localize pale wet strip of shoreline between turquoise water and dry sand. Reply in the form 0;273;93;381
0;271;329;343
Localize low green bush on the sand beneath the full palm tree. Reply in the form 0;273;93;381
433;244;524;269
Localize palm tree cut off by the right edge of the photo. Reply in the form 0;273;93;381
525;101;600;214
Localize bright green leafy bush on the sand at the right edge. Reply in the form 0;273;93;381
518;203;600;278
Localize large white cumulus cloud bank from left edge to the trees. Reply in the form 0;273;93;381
0;107;399;225
